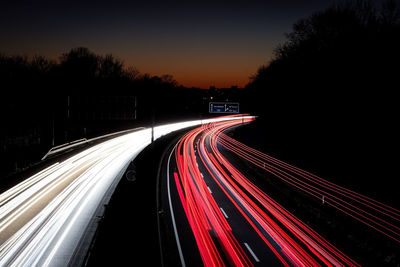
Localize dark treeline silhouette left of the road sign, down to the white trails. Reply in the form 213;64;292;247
0;47;207;175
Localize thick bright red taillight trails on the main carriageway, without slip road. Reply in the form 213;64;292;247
174;118;358;266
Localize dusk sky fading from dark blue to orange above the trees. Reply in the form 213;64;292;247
0;0;344;88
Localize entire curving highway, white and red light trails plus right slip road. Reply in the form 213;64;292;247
0;115;400;266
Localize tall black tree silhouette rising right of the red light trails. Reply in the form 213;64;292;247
242;0;400;183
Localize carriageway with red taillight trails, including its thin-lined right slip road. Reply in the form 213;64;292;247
166;118;382;266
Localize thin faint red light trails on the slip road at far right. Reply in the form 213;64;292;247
217;133;400;242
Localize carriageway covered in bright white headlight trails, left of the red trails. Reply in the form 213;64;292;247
0;117;247;266
